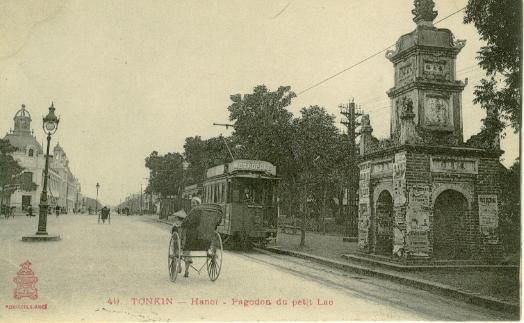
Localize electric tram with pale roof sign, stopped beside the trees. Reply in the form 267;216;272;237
182;160;279;249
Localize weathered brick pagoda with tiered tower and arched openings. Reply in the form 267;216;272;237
359;0;502;259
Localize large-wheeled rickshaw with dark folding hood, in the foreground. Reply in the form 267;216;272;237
168;204;223;282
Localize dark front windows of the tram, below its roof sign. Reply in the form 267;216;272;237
232;178;273;205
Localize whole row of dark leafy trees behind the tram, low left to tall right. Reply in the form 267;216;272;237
141;85;347;239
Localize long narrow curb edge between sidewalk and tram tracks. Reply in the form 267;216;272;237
265;247;520;318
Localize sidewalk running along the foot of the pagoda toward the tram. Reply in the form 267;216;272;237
268;232;520;310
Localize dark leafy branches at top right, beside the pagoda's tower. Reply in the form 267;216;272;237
464;0;522;132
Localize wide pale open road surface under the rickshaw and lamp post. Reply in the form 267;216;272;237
0;215;508;322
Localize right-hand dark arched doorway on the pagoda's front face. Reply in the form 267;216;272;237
433;190;471;259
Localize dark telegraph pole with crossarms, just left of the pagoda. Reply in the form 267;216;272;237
340;100;362;237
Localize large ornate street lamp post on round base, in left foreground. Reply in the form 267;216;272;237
22;103;60;241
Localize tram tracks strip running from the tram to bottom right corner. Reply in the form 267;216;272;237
231;248;512;321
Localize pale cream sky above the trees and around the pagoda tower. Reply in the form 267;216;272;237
0;0;519;205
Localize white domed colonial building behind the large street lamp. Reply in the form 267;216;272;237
4;105;82;212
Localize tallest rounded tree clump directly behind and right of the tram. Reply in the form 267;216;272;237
228;85;347;225
